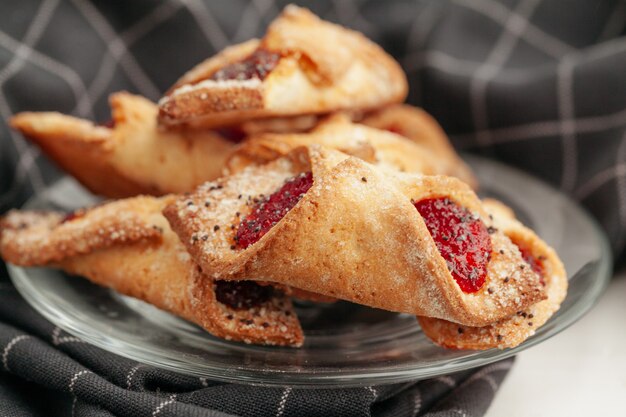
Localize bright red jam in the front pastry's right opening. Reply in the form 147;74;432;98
414;198;491;293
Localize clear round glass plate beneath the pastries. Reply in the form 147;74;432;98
9;157;611;387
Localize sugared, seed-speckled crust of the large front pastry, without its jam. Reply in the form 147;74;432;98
164;146;545;326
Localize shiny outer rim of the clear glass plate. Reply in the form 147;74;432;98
7;156;612;388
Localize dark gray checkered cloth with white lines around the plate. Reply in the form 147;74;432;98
0;0;626;416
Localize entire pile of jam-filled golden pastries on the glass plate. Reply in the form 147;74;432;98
0;6;567;349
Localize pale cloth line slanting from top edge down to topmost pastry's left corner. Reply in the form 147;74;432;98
72;0;160;100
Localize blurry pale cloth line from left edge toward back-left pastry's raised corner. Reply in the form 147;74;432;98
0;31;93;116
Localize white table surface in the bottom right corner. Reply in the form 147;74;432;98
486;272;626;417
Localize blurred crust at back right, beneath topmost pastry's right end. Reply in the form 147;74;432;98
361;104;478;188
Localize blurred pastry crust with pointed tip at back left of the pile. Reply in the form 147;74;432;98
11;92;234;198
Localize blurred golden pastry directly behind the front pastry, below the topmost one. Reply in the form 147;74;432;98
226;114;452;179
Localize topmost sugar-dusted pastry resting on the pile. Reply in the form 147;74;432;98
159;5;407;128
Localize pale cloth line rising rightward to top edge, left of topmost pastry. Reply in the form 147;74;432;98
75;1;183;114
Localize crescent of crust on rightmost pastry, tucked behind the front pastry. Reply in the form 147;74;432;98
418;200;567;349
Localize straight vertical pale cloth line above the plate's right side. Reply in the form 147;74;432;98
556;55;578;191
